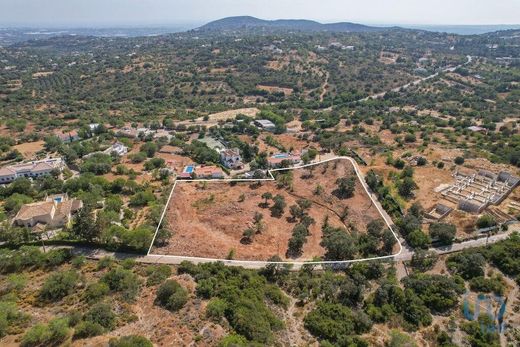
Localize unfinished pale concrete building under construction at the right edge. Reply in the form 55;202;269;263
441;170;520;213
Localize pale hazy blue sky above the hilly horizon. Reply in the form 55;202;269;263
0;0;520;27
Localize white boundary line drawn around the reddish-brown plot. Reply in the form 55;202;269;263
147;156;403;268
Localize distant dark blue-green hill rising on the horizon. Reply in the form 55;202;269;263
195;16;390;32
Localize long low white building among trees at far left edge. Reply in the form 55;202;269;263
0;158;65;184
